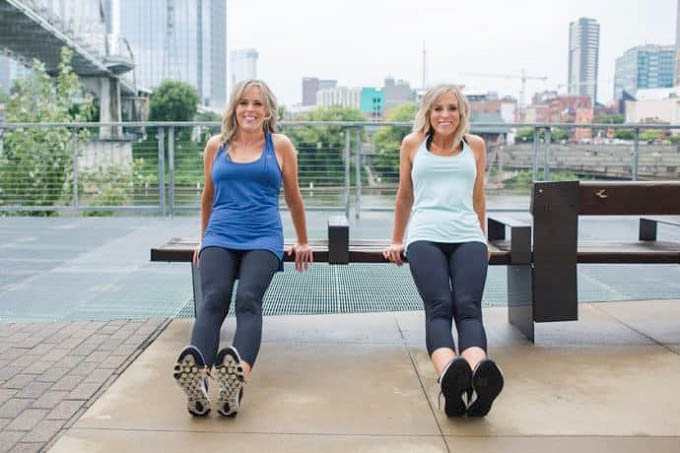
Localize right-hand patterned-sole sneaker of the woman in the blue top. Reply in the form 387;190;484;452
214;346;246;417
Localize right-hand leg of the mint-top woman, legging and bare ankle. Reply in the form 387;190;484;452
449;242;489;369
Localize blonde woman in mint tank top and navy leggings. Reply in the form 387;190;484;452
383;85;503;417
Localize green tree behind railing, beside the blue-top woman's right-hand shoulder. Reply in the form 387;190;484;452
282;106;366;186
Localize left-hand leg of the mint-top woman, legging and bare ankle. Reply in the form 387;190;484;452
408;241;456;376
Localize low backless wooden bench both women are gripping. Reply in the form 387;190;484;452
151;216;512;316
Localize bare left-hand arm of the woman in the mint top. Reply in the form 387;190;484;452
383;134;422;266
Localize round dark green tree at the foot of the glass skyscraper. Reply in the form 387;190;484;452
149;80;200;121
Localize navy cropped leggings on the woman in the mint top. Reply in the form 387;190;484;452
408;241;489;355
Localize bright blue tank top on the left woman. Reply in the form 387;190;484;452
201;132;283;270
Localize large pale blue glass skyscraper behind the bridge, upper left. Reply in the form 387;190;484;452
102;0;227;109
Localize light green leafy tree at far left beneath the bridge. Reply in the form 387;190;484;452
0;47;92;215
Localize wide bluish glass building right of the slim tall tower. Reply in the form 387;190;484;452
614;44;675;101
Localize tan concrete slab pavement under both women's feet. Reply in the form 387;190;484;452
50;300;680;453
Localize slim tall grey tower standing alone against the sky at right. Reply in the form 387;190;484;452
567;17;600;105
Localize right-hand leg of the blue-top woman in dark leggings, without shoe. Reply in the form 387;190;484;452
234;250;279;377
